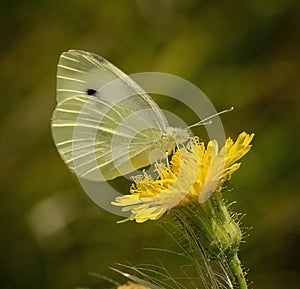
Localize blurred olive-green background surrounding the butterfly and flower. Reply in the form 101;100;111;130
0;0;300;289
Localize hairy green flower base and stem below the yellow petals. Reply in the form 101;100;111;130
168;192;248;289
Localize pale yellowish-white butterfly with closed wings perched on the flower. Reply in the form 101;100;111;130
51;50;189;181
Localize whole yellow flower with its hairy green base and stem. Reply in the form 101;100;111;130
113;132;254;289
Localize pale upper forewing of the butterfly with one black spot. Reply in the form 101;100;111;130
57;50;168;129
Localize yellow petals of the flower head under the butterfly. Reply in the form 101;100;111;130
112;132;254;223
